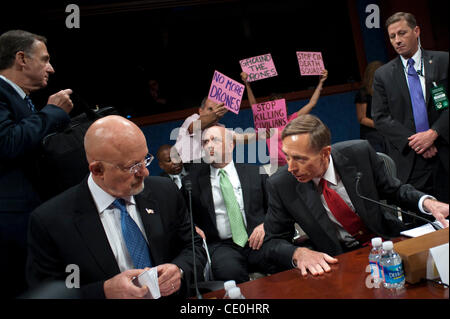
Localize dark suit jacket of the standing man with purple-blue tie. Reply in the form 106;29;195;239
372;50;449;182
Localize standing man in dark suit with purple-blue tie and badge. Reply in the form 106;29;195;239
372;12;449;203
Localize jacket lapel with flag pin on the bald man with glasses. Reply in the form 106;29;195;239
134;191;167;266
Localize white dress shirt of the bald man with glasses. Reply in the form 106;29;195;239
88;174;148;272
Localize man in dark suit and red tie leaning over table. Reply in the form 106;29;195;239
264;115;449;275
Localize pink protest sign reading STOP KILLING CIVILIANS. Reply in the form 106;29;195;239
252;99;287;129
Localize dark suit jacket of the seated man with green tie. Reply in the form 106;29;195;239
183;163;268;243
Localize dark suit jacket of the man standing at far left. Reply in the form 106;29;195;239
0;78;70;212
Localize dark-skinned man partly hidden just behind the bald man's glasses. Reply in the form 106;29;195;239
156;144;188;189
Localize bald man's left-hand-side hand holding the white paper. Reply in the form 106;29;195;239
103;269;148;299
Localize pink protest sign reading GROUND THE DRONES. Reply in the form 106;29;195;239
239;53;278;82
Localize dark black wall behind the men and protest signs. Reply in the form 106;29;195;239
0;0;360;117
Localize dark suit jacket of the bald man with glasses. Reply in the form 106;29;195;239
27;177;206;298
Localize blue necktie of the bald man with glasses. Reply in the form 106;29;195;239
113;198;152;269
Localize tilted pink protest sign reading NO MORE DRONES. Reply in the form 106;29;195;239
208;71;245;114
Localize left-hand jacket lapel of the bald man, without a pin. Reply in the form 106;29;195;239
75;179;120;278
